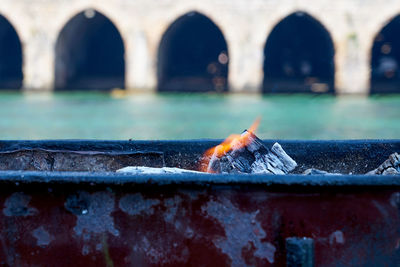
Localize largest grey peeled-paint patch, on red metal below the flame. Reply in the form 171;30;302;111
202;197;276;266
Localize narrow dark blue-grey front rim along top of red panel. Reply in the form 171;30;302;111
0;171;400;187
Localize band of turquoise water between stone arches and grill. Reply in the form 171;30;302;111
0;93;400;139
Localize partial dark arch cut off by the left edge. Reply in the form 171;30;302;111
0;15;23;89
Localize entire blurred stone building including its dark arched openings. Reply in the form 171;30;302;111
0;0;400;94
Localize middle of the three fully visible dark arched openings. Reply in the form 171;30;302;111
157;12;229;92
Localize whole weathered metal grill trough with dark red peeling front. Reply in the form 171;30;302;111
0;140;400;266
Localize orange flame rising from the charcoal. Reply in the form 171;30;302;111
200;118;261;173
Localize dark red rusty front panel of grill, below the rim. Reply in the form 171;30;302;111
0;183;400;266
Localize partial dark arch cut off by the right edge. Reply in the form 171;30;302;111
371;15;400;94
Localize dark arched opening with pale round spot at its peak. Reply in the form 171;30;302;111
55;9;125;90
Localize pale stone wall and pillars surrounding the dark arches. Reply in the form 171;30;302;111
0;0;400;94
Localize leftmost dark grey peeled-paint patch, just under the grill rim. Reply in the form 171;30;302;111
3;192;38;216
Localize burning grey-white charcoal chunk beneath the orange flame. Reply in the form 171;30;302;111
208;131;297;174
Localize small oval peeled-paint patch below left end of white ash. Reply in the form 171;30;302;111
119;193;160;215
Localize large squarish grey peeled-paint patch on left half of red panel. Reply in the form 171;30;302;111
74;192;119;238
